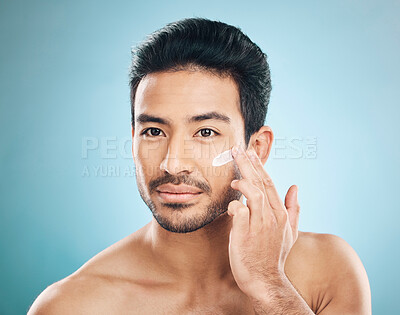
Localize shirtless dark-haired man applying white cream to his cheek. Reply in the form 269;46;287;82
29;18;371;315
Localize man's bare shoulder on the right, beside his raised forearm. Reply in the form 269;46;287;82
287;232;371;315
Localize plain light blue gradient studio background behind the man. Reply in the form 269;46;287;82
0;0;400;314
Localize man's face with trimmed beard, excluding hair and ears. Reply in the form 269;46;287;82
132;71;244;233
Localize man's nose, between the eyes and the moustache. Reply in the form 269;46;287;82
160;140;194;175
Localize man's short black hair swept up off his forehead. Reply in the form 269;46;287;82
129;17;271;146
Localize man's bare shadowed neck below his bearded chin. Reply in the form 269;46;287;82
147;213;235;287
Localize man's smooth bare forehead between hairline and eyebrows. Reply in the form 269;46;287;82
135;71;241;121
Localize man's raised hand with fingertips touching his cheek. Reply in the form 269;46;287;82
228;147;300;296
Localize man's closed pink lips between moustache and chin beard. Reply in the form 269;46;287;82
157;184;202;202
